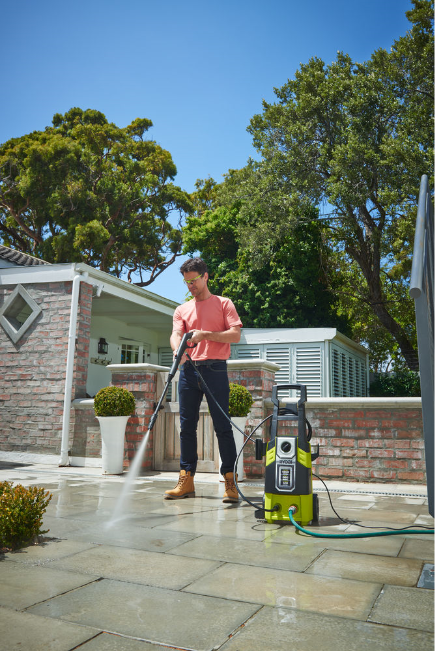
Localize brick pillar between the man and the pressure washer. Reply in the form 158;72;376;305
228;359;279;479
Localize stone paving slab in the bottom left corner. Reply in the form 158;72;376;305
0;606;99;651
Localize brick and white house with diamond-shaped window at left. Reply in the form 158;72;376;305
0;246;177;465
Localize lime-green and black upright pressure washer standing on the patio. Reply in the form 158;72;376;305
255;384;319;526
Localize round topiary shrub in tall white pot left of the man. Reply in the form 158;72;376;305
94;387;136;475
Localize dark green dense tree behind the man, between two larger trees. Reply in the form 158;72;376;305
183;177;350;334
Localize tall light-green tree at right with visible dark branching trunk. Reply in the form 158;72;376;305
221;0;435;369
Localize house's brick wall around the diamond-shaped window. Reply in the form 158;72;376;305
0;282;92;454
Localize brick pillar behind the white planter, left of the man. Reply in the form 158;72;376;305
107;364;168;470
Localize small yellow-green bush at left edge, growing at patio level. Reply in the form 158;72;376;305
0;481;52;549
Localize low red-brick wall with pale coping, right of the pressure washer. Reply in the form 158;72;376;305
307;398;426;483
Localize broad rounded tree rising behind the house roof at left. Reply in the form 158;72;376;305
0;108;192;286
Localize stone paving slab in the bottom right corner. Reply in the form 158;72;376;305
219;607;435;651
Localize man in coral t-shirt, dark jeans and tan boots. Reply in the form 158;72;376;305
165;258;242;502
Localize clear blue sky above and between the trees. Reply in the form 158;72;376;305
0;0;412;302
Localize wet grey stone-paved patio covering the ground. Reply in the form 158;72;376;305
0;462;435;651
